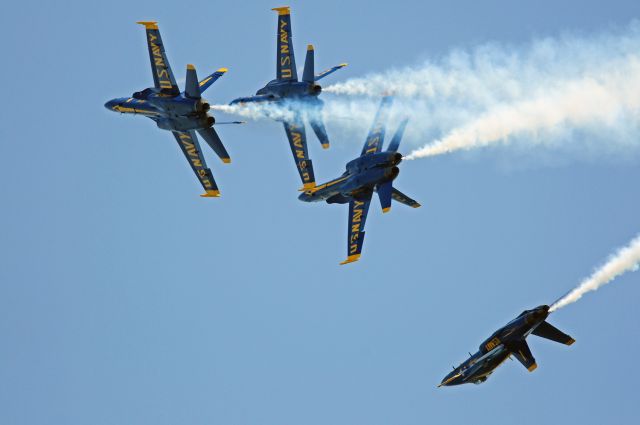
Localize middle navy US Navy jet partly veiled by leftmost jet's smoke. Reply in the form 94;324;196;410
231;6;347;189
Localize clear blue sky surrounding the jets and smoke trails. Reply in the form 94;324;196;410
0;0;640;425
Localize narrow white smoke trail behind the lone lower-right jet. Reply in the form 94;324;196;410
549;235;640;311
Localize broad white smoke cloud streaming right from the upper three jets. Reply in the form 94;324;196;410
324;22;640;159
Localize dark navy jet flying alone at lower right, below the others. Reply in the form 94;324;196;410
438;305;575;387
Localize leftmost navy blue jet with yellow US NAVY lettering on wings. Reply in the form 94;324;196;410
104;22;236;197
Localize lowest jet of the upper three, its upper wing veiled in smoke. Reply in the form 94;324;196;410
299;96;420;264
